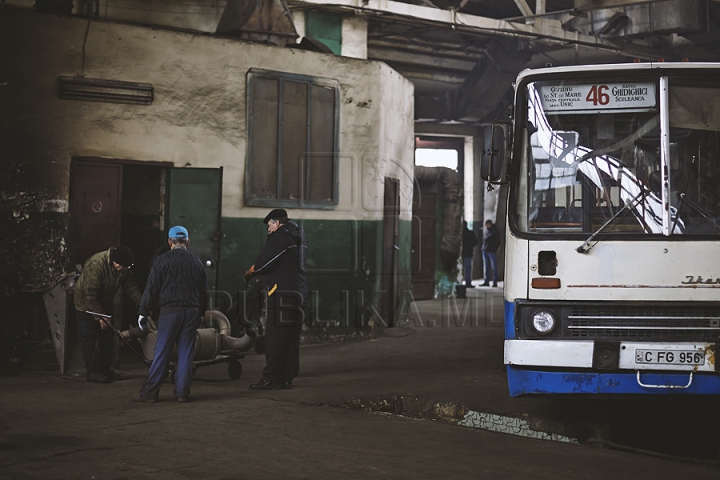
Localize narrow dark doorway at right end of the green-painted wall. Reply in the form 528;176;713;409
381;177;400;327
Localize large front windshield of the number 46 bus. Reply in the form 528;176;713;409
511;77;720;237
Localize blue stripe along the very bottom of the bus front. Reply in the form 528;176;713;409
506;365;720;397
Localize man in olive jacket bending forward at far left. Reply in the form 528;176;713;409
73;245;142;383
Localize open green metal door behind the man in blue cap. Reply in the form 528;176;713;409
168;168;222;290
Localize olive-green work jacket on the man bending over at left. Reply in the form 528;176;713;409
74;250;142;315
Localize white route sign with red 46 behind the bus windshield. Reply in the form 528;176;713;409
540;83;656;113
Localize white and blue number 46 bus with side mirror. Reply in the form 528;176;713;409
480;62;720;396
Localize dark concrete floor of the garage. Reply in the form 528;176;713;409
0;289;720;480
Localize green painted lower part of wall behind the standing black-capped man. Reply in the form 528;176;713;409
219;217;411;329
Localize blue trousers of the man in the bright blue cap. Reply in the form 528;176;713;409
140;308;199;399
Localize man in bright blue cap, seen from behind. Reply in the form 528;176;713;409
132;225;207;403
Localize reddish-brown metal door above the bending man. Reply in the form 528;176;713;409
69;160;122;266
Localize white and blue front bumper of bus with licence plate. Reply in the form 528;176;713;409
505;340;720;396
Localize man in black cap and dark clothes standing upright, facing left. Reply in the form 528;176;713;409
245;208;307;390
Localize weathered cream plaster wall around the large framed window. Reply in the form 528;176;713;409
0;7;413;328
